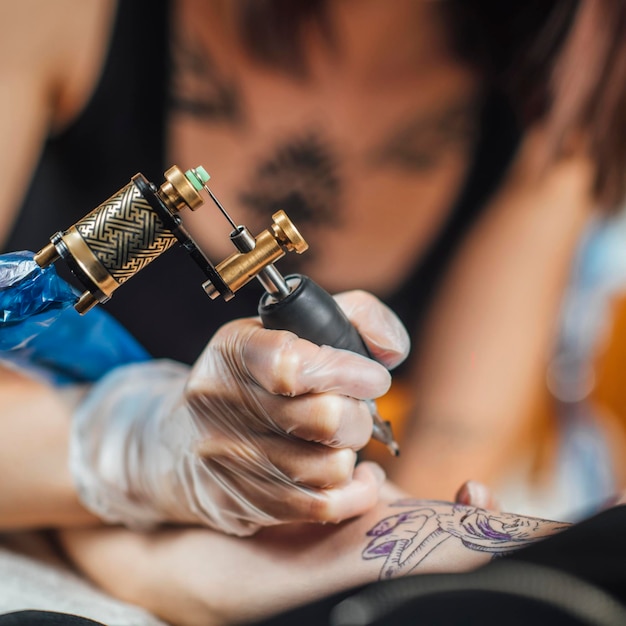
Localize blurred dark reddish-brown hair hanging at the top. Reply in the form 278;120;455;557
239;0;626;207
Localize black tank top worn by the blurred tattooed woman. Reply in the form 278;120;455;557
6;0;519;363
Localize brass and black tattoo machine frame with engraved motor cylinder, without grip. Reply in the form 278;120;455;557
35;166;308;314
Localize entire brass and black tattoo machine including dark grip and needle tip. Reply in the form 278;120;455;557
35;166;399;455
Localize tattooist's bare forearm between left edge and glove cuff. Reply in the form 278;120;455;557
0;365;96;529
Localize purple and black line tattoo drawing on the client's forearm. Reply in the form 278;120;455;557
362;500;569;579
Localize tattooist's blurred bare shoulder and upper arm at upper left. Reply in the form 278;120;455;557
0;0;116;243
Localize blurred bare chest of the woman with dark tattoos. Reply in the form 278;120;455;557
170;0;477;295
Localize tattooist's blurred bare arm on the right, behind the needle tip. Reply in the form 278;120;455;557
393;142;589;497
